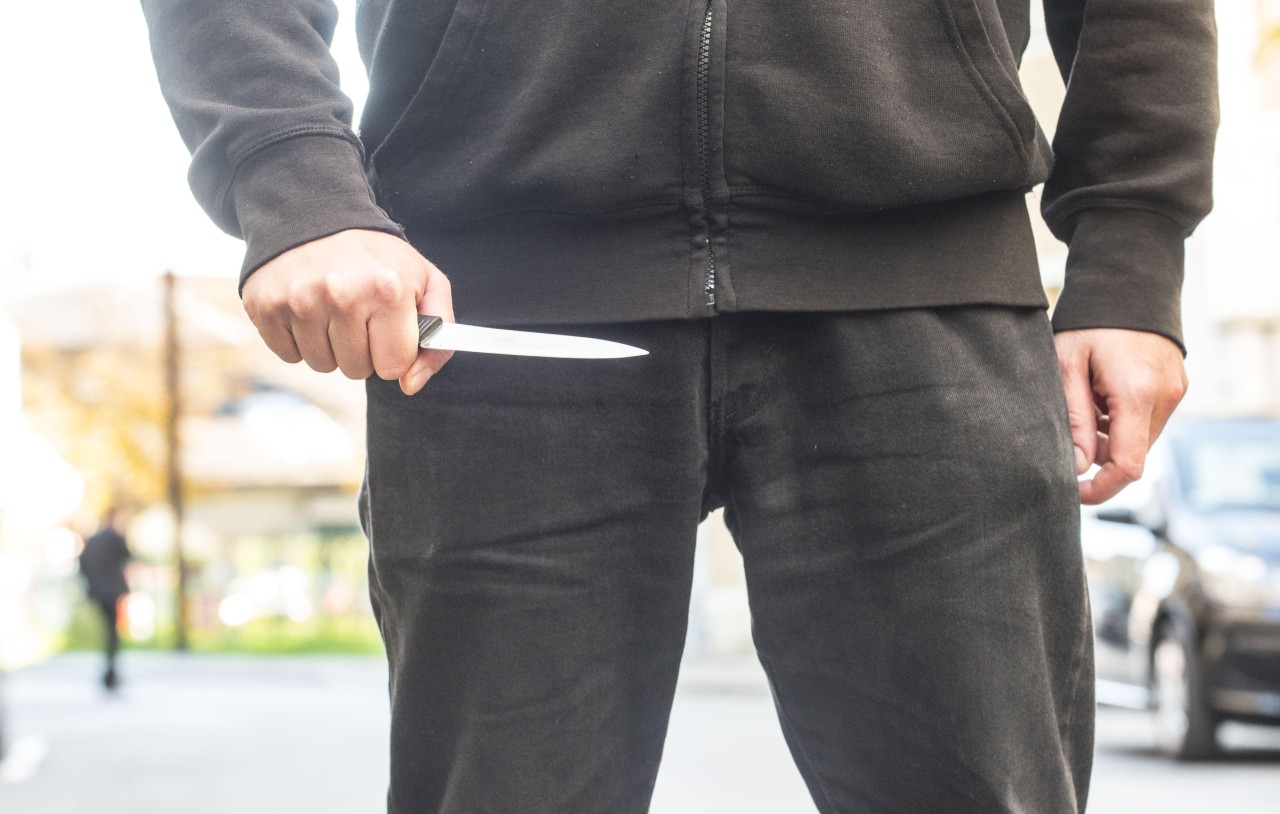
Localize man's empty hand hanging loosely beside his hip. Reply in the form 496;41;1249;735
1053;328;1187;504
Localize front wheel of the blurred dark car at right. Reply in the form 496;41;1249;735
1151;622;1219;760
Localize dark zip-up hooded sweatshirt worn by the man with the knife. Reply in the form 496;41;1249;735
142;0;1217;342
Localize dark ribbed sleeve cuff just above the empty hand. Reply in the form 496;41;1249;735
1053;209;1187;353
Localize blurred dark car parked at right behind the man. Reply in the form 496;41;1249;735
1082;419;1280;759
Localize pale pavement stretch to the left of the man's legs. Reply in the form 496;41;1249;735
0;653;387;814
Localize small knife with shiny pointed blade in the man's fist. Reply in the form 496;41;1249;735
417;315;649;358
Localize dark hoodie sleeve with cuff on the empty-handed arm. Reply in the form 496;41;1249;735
1042;0;1219;347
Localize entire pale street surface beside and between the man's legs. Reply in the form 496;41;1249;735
0;653;1280;814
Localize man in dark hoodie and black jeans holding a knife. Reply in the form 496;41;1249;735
143;0;1216;813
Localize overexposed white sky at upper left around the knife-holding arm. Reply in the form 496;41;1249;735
0;0;365;289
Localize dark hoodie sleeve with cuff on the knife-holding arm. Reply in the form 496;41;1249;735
142;0;402;293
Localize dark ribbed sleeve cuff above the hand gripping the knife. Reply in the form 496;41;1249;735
232;134;404;289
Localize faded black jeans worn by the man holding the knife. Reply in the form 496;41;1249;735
361;307;1093;814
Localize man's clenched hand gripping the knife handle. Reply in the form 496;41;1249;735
243;229;453;395
